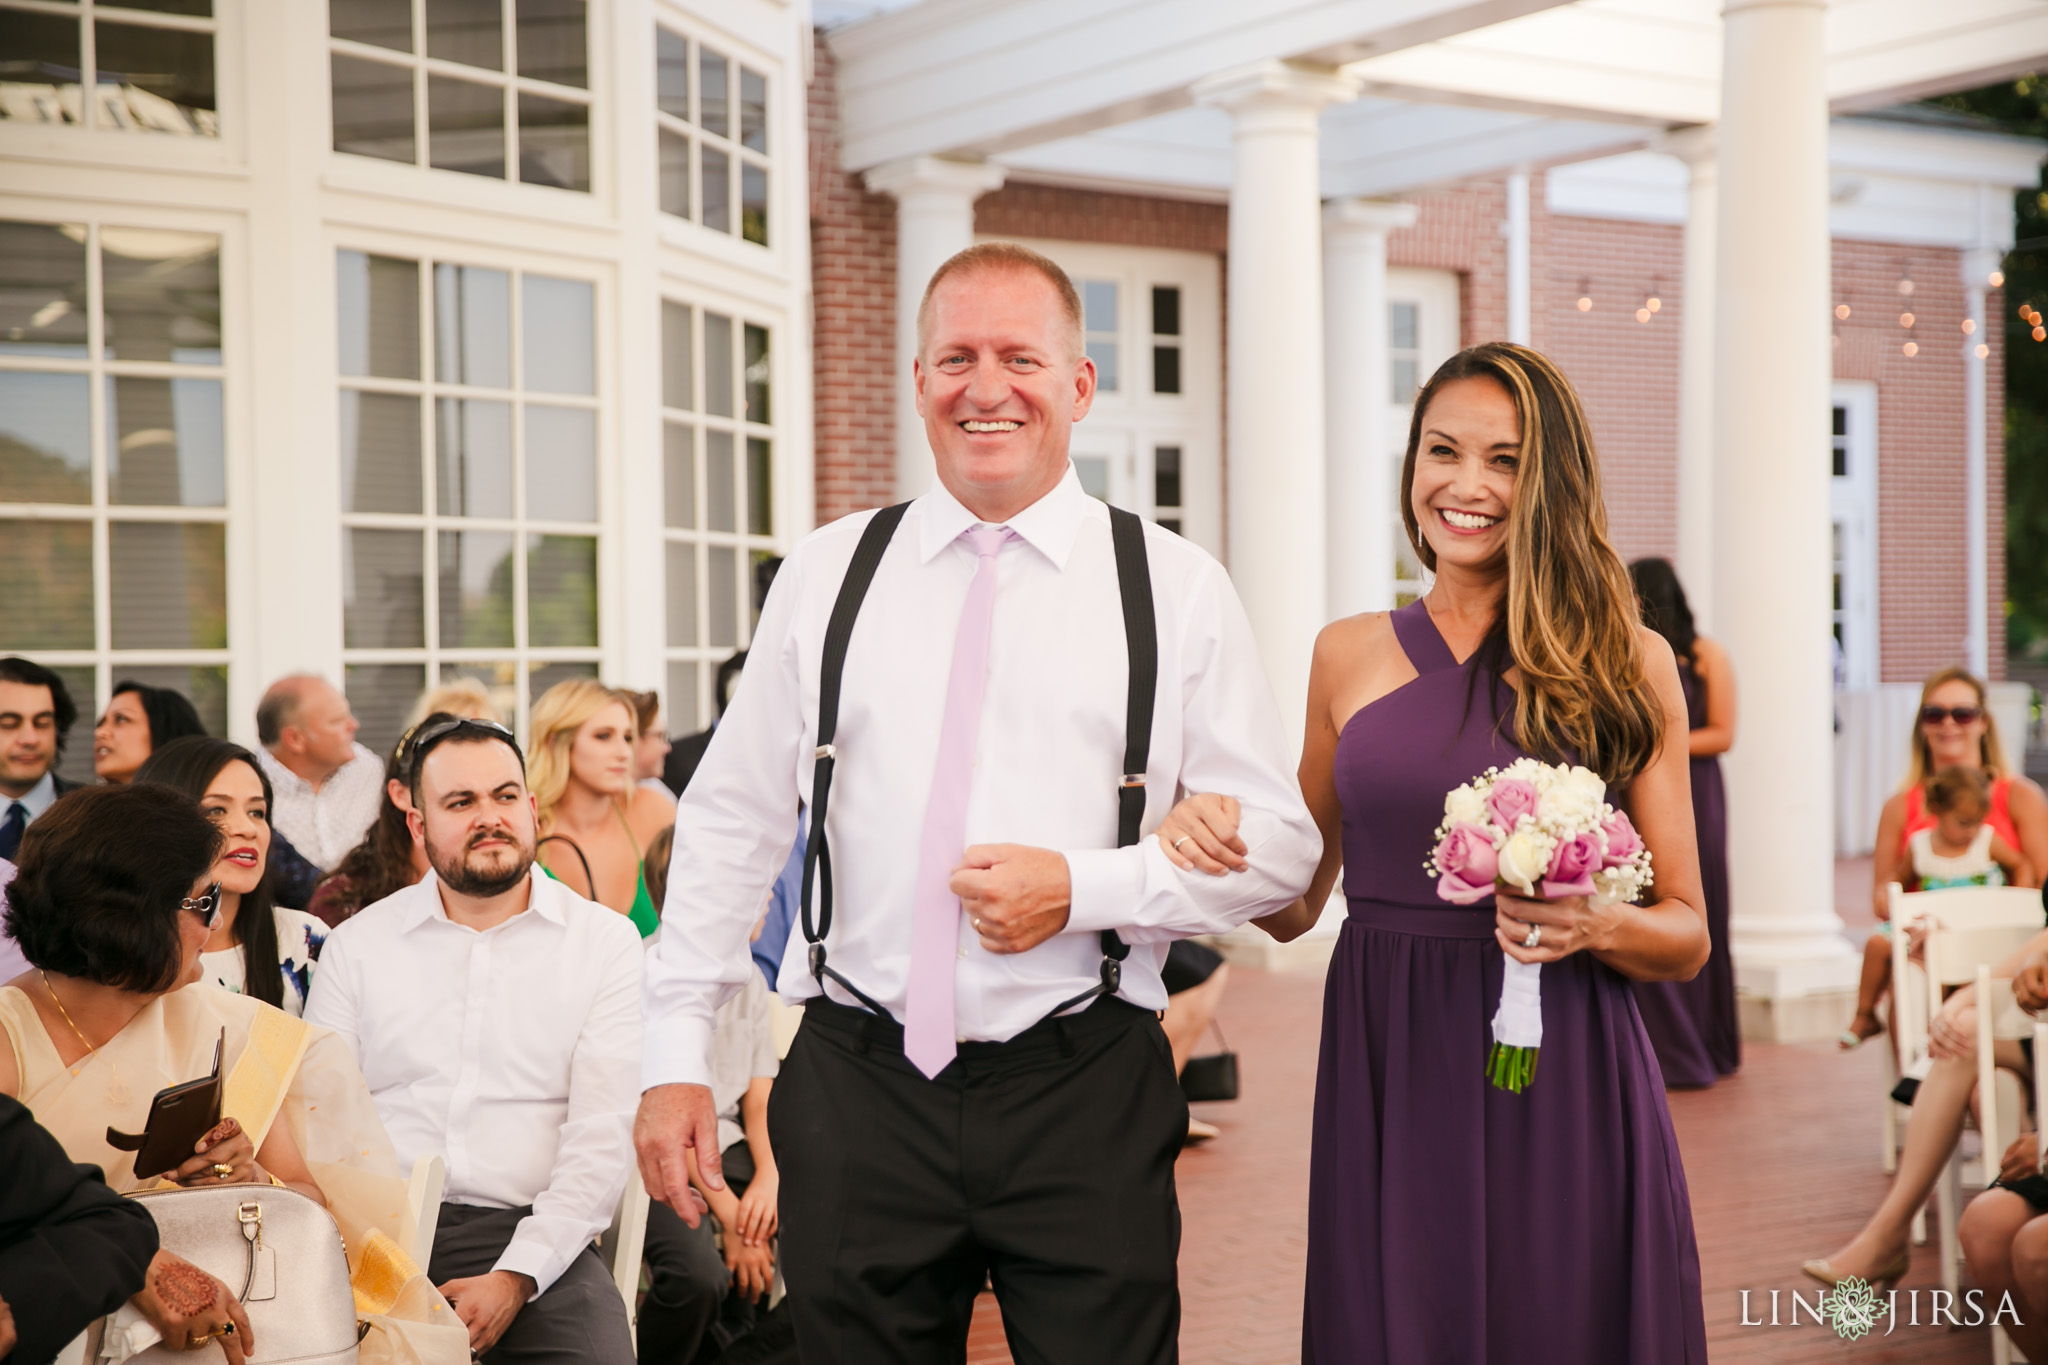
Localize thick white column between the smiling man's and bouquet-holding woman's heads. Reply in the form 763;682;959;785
1194;61;1358;747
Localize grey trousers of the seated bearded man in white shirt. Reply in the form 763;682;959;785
438;1203;633;1365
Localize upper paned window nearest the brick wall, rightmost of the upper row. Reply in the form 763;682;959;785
653;25;770;246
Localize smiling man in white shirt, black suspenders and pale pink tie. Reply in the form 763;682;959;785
635;244;1321;1365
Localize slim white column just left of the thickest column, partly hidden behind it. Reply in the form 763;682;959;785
1661;125;1720;634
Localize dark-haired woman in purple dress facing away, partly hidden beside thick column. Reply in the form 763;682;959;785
1628;559;1743;1089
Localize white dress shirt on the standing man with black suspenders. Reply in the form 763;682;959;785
641;467;1323;1087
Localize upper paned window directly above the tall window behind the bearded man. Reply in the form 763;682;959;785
328;0;592;190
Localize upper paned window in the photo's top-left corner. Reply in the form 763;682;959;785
0;0;221;137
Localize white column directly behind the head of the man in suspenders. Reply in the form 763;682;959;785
866;156;1004;497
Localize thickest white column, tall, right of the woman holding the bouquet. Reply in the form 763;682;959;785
1714;0;1858;1038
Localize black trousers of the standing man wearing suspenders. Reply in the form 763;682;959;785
768;999;1188;1365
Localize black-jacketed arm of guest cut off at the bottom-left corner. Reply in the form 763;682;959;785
0;1097;158;1365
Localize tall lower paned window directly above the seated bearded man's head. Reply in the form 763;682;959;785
338;252;600;747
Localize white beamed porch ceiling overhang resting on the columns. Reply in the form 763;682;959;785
831;0;2048;199
